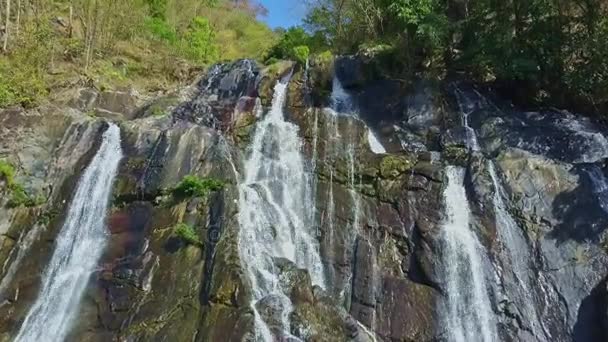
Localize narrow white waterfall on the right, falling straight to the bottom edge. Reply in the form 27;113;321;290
442;166;497;342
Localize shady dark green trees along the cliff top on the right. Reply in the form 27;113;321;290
280;0;608;116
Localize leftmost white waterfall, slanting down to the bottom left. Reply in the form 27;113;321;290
15;124;122;342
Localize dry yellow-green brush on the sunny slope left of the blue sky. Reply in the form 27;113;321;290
0;0;276;108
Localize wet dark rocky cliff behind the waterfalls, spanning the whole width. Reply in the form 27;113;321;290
0;57;608;341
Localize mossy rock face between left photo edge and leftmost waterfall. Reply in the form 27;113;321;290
0;107;105;340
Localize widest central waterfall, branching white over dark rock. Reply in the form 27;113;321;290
238;77;325;341
